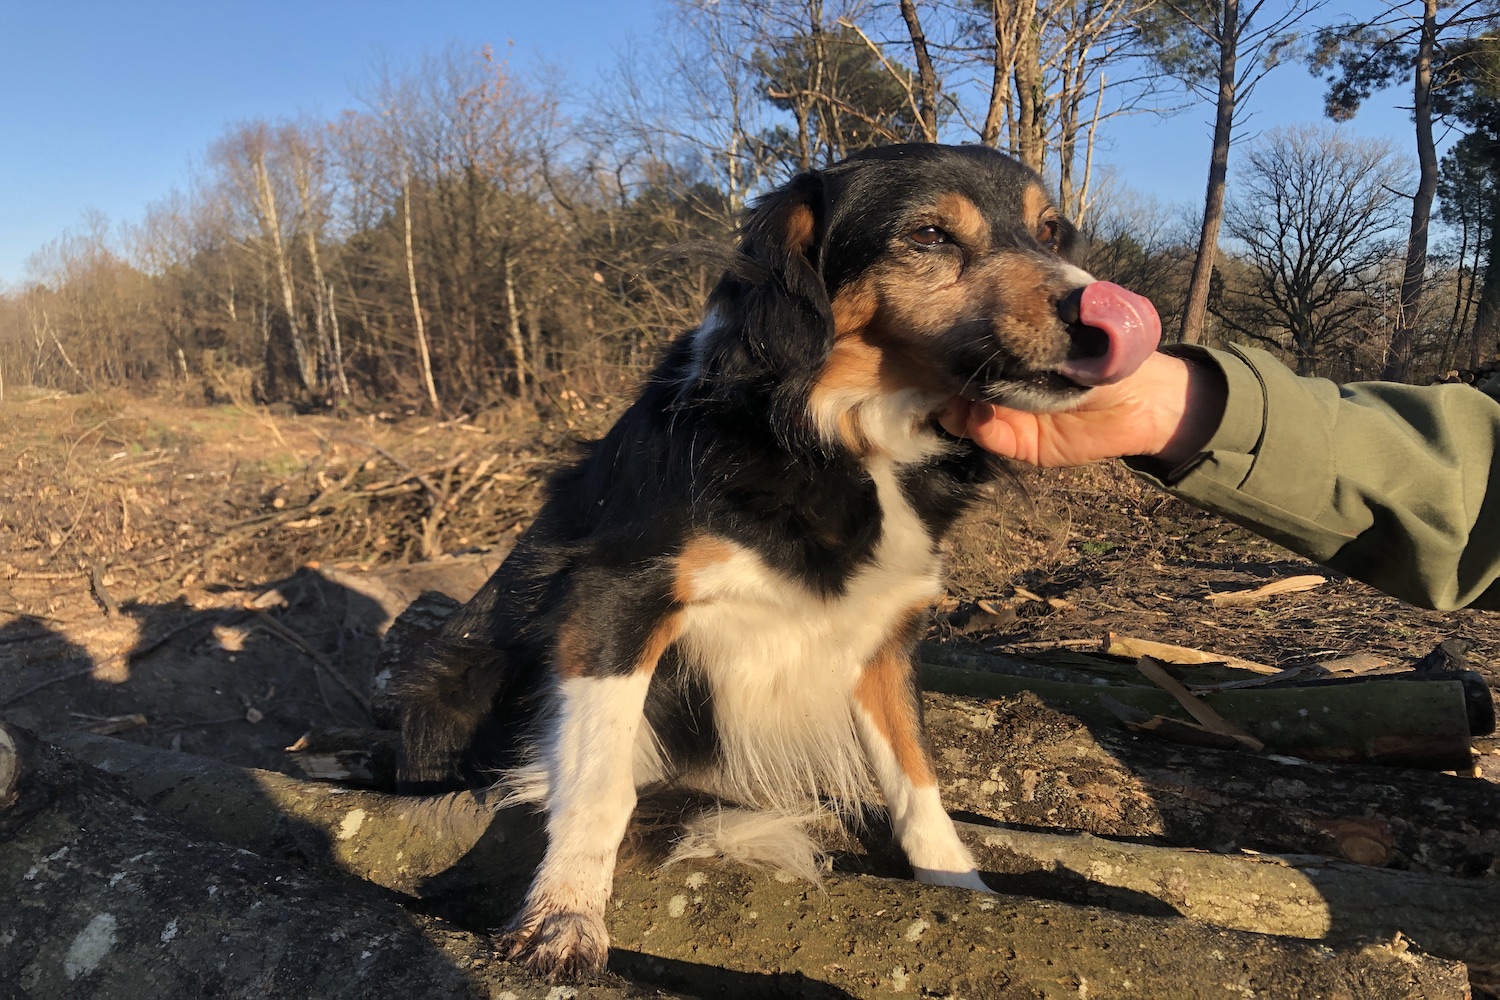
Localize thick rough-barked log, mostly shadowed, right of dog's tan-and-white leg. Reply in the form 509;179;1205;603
924;693;1500;877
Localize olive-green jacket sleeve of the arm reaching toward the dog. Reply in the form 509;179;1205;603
1130;348;1500;609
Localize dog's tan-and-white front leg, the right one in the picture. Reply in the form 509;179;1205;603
854;646;992;892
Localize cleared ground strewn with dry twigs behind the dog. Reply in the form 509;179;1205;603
0;394;1500;995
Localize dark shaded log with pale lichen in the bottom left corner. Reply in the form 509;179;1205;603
0;726;669;1000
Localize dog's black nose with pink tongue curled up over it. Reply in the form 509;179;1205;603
1058;282;1161;385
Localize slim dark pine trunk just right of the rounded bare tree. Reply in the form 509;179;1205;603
1383;0;1437;381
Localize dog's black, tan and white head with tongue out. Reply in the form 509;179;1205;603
705;144;1160;450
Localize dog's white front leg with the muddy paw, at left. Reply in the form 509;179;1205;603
504;669;651;979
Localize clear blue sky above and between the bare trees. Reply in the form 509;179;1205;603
0;0;1410;288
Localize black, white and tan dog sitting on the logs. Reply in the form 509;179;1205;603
401;144;1160;978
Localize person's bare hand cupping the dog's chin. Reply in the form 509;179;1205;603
939;354;1226;468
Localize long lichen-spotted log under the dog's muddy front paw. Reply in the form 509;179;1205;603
23;736;1467;1000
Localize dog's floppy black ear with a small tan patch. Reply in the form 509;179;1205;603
714;172;834;379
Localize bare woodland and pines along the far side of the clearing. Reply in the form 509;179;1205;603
0;0;1500;414
